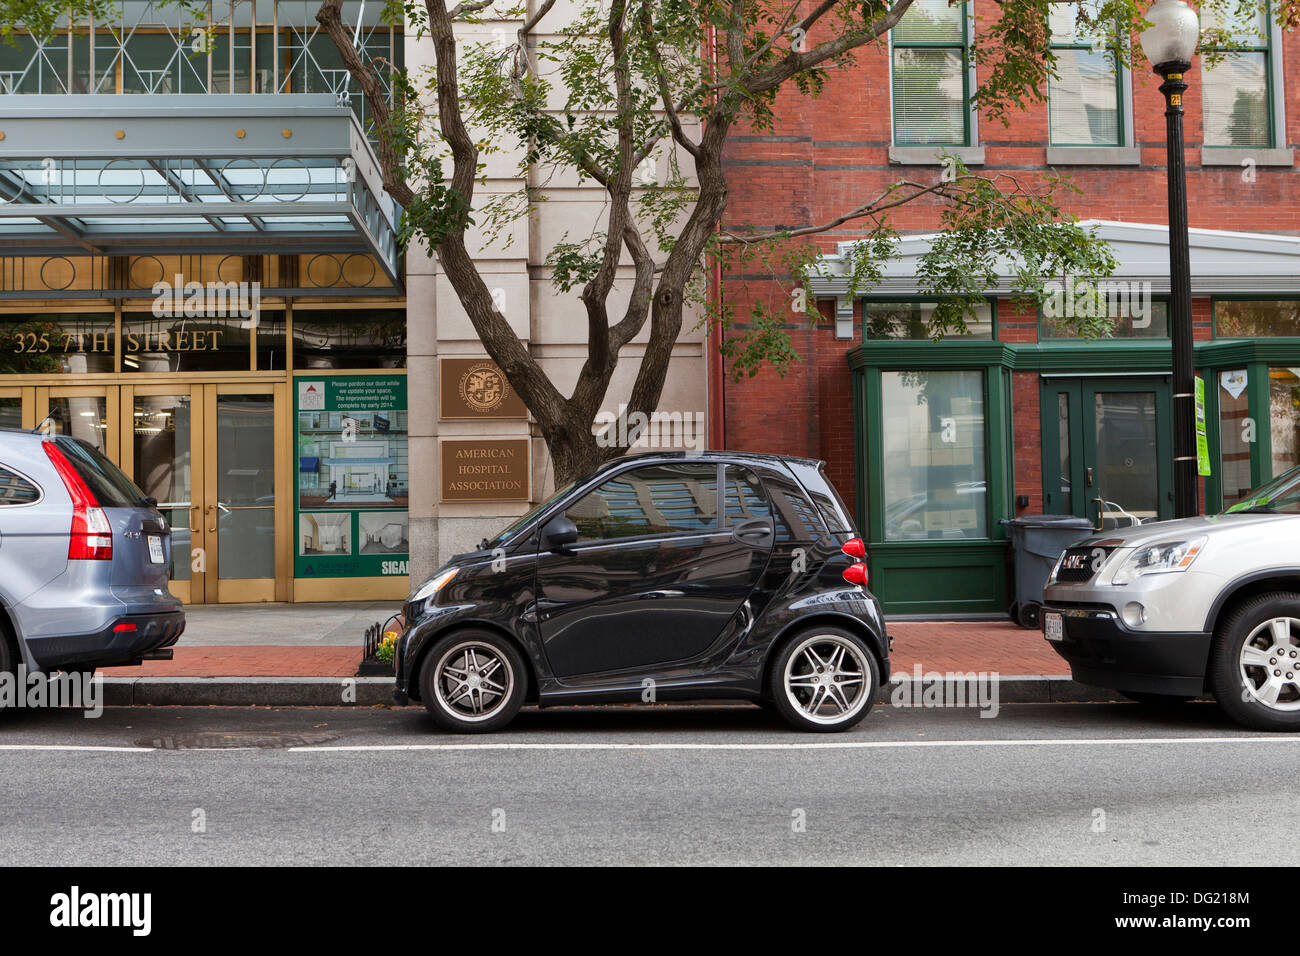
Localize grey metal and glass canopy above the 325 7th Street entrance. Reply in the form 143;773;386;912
0;94;400;285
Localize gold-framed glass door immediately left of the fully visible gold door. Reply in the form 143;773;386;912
120;385;207;604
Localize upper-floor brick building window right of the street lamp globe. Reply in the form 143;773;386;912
1201;7;1274;150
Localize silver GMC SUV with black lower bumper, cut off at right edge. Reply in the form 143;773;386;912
1043;468;1300;731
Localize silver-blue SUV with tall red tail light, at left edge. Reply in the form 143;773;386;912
0;431;185;672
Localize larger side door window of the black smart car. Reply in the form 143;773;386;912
564;462;718;541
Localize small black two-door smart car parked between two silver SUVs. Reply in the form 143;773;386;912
394;453;889;732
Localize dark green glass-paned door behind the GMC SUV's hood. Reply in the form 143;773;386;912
1041;376;1173;531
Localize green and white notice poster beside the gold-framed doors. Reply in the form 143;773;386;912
294;375;411;578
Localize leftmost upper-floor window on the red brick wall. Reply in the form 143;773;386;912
891;0;971;146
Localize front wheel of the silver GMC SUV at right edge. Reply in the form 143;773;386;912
1210;592;1300;731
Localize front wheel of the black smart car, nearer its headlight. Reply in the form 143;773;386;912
420;631;528;734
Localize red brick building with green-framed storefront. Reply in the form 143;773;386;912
722;0;1300;613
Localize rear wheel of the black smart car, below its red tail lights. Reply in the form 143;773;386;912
768;627;880;734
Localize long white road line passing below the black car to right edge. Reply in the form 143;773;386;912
287;734;1300;753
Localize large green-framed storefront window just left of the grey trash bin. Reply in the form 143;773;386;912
880;371;988;541
